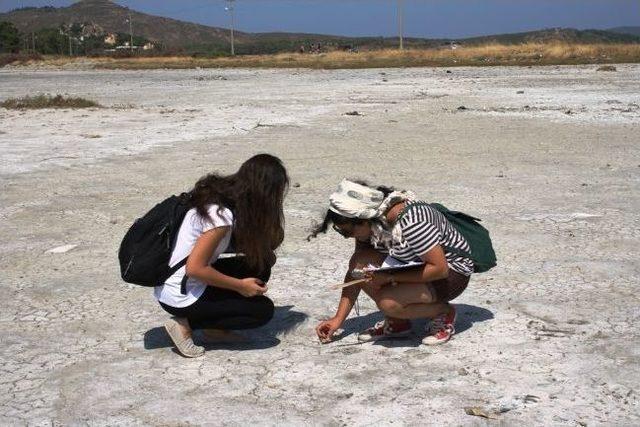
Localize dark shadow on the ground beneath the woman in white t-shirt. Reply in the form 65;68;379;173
144;305;308;350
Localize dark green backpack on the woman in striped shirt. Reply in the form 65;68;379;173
397;202;496;273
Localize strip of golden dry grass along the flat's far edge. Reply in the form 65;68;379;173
86;43;640;69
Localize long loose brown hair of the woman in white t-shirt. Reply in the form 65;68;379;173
190;154;289;269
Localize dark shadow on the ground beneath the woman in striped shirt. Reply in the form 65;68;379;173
339;304;494;347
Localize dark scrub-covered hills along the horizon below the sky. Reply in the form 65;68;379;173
0;0;640;55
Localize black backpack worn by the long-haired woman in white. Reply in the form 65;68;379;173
118;193;191;286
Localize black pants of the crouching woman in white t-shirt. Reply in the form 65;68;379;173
160;258;274;330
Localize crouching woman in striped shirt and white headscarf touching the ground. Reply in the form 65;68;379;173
310;180;473;345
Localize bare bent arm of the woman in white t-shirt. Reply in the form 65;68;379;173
186;227;267;297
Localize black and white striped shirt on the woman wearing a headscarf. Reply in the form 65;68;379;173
389;201;473;276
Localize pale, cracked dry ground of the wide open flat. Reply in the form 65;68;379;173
0;65;640;426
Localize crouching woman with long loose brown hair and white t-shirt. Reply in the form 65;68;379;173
155;154;289;357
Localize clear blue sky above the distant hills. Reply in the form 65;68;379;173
0;0;640;38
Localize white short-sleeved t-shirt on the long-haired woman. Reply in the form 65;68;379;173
154;205;233;308
